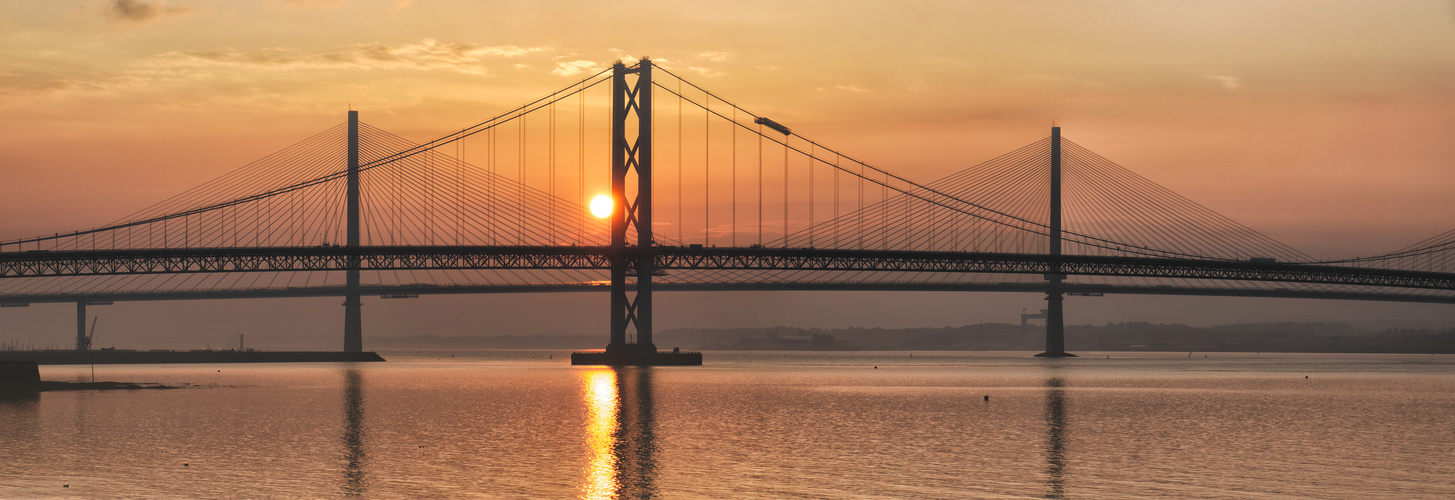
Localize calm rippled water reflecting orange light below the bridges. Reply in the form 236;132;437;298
0;352;1455;499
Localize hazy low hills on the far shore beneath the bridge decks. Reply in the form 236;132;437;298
370;323;1455;353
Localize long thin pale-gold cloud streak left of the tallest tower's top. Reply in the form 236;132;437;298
151;38;544;76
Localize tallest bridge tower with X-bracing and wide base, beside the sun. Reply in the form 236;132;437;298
570;58;703;366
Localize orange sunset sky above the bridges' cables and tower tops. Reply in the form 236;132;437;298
0;0;1455;340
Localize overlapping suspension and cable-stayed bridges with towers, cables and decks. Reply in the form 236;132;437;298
0;60;1455;359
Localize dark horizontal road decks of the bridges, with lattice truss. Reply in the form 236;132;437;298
0;246;1455;304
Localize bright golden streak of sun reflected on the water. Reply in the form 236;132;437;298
581;369;620;499
